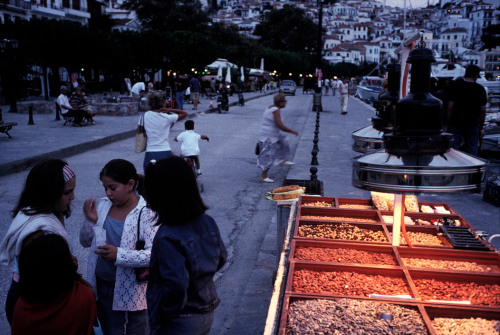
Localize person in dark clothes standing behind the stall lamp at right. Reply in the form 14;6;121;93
445;65;487;156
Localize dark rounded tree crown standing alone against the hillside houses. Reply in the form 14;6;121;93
255;5;318;52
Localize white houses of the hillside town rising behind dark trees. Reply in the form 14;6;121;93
0;0;500;79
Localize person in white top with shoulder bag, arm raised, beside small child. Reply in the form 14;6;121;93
139;92;187;171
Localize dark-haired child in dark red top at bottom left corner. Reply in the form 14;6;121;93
12;234;97;335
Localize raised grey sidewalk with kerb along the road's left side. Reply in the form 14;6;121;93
0;91;277;176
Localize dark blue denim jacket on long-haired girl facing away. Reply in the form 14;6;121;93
146;214;227;329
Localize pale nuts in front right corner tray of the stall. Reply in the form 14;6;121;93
432;318;500;335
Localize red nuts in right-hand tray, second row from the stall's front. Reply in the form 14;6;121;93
413;279;500;306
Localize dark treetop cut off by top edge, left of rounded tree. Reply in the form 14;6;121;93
122;0;210;32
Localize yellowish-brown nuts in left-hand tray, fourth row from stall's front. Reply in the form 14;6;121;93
299;223;387;242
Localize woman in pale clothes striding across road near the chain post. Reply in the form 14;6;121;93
257;93;299;183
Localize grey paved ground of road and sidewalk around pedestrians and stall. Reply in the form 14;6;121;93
0;91;500;335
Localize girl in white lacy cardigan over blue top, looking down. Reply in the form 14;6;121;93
80;159;157;335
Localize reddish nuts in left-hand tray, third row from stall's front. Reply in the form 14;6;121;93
294;246;398;265
